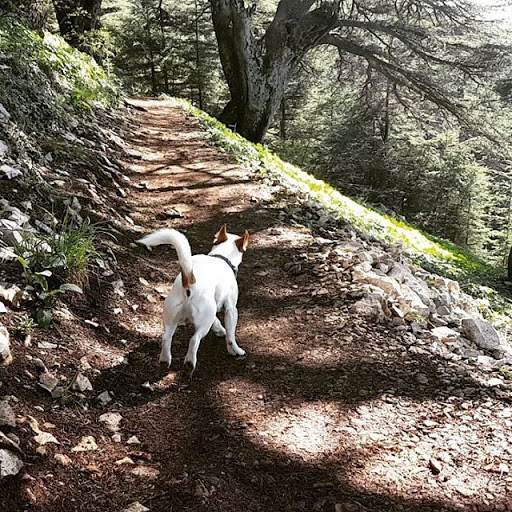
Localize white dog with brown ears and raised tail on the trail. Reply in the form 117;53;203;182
137;224;249;375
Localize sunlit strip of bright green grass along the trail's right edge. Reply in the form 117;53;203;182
174;99;499;279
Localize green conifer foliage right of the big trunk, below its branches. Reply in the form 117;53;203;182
268;46;512;264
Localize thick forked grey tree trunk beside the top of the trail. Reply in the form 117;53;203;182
210;0;335;142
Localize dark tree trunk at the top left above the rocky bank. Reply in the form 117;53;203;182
53;0;102;48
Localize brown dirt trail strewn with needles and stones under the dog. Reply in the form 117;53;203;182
0;100;512;512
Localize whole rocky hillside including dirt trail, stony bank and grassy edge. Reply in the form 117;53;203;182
0;27;512;512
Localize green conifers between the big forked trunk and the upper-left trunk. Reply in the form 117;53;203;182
103;0;226;110
